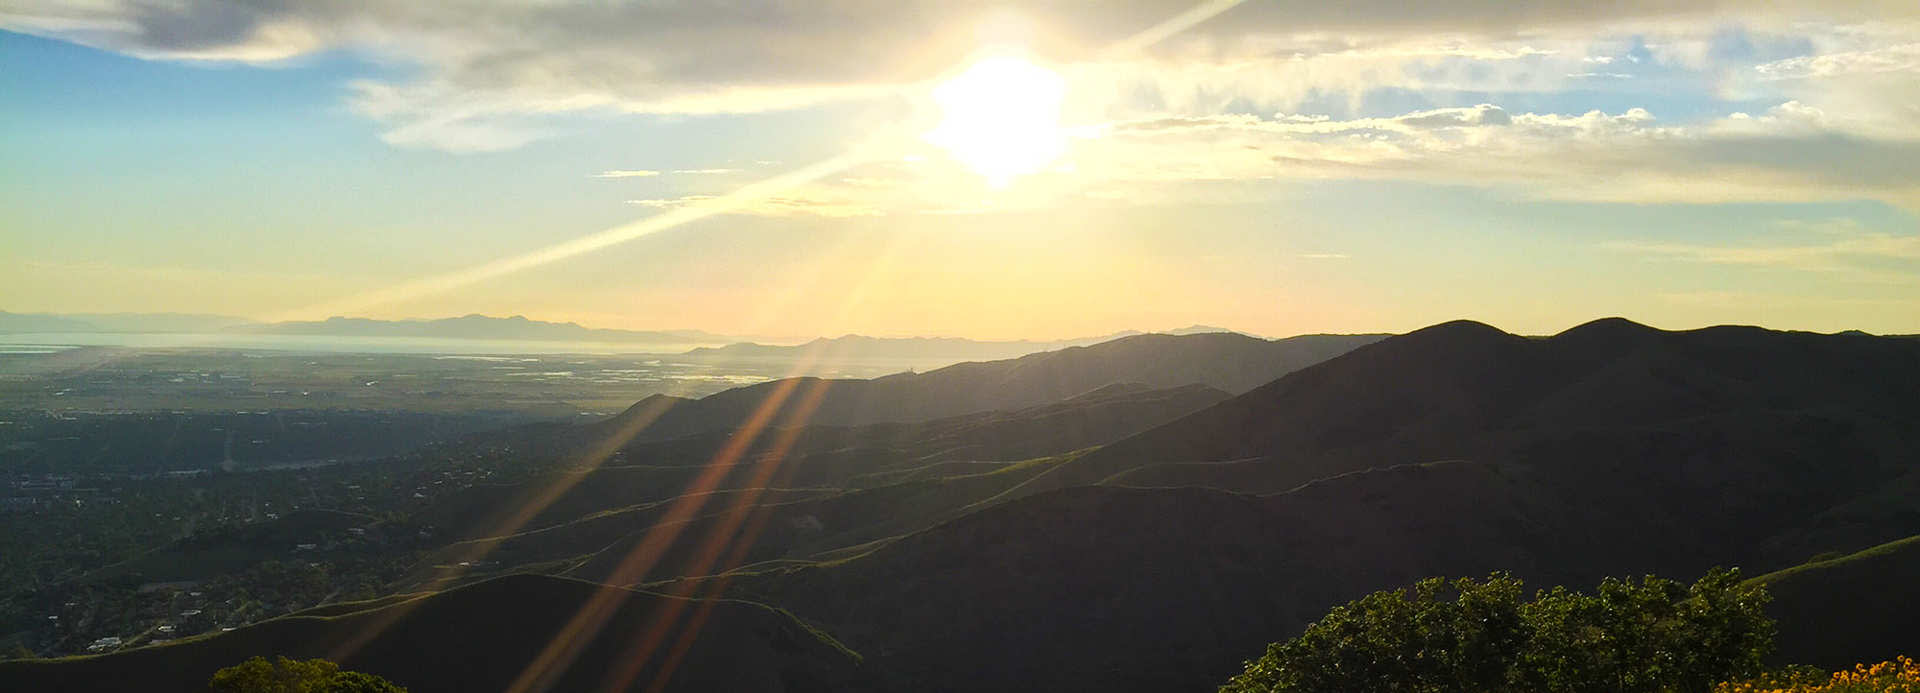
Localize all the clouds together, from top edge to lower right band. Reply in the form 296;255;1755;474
0;0;1920;208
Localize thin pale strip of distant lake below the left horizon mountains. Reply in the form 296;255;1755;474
0;332;718;353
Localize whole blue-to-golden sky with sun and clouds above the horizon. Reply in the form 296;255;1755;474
0;0;1920;338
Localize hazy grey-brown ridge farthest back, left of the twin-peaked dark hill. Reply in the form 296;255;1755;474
595;332;1382;440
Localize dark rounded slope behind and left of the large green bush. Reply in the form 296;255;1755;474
733;470;1588;691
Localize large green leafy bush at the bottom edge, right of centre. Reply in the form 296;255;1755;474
1221;568;1774;693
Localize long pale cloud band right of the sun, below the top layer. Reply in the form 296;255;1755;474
1071;102;1920;209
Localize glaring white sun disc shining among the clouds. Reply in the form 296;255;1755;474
925;56;1066;188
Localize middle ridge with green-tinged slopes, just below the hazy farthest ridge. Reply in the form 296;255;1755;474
422;384;1227;538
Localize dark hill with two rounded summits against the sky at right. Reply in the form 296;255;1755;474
1035;319;1920;514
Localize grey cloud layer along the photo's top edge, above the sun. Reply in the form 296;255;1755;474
0;0;1920;152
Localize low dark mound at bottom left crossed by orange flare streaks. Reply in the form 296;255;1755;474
0;576;862;693
